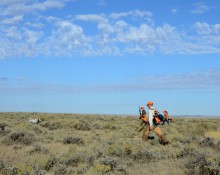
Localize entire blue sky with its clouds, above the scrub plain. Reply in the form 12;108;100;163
0;0;220;116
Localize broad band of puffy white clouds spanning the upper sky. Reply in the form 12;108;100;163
0;0;220;59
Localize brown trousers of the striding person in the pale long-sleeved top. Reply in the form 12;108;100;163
142;125;168;144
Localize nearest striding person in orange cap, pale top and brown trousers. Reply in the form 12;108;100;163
142;101;169;145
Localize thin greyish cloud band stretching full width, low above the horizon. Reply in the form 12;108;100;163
0;69;220;94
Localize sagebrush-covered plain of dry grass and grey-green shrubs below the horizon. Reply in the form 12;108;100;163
0;113;220;175
